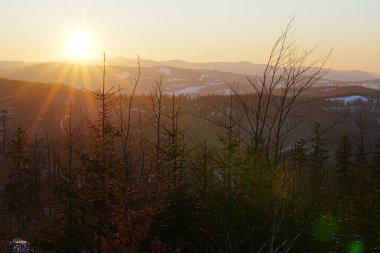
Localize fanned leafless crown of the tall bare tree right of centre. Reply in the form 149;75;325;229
230;19;330;172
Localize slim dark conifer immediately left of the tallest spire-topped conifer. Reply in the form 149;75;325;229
54;104;88;252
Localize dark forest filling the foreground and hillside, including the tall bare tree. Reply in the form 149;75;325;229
0;22;380;253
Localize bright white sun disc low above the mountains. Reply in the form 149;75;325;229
67;32;93;60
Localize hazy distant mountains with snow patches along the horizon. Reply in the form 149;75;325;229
0;57;380;95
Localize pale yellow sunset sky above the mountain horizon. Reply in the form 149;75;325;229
0;0;380;73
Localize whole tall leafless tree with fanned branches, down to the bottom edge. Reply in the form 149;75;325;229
205;19;331;252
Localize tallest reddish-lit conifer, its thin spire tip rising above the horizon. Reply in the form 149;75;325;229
82;53;121;251
